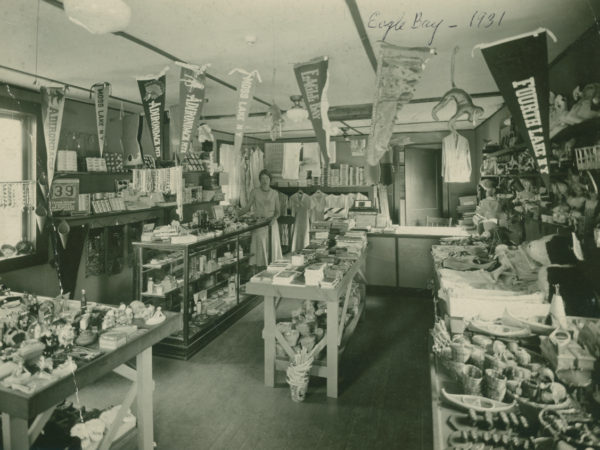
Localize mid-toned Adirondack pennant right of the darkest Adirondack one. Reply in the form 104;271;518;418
175;62;208;157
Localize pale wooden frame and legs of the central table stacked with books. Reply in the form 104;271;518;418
246;249;366;398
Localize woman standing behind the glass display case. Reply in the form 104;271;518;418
239;169;282;267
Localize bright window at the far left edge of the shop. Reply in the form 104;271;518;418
0;108;37;261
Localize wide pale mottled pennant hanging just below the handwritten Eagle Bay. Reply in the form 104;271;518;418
367;42;435;166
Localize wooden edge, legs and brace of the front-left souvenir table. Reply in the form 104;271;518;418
0;312;182;450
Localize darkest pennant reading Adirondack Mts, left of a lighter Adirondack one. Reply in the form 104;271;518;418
137;66;169;158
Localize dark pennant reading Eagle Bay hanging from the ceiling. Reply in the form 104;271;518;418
294;56;331;167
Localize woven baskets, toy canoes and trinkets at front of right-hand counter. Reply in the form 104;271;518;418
432;318;600;449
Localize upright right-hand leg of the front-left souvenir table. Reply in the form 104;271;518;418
136;347;154;450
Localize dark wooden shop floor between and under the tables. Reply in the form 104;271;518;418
71;295;432;450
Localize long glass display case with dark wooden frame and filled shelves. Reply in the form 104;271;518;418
133;221;270;359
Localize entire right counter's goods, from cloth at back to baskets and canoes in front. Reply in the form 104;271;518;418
432;233;600;449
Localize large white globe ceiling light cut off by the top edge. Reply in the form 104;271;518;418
63;0;131;34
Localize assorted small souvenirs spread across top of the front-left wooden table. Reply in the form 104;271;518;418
0;289;165;394
